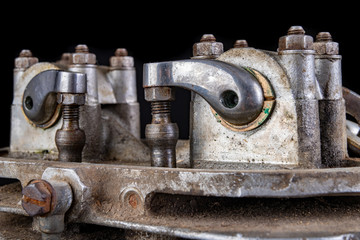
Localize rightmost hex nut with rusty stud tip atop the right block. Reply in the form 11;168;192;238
314;32;339;55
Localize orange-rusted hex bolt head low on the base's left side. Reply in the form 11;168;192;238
22;180;54;217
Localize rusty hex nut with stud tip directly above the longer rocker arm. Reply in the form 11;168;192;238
193;34;224;58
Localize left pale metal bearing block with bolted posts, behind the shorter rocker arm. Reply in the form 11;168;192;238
10;44;150;162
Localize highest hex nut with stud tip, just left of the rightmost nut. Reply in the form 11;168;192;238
278;26;314;51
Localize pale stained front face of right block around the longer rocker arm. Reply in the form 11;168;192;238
194;47;300;169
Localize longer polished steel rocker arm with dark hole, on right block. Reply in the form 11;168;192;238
143;59;264;125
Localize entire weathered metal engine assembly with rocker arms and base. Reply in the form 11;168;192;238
0;26;360;240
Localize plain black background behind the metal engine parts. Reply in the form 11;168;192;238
0;1;360;147
